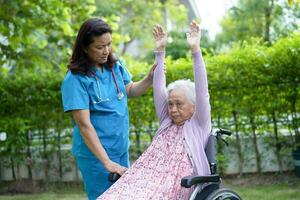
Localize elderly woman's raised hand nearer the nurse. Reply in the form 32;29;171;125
153;25;168;51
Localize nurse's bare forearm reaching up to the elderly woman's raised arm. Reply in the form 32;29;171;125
126;64;156;97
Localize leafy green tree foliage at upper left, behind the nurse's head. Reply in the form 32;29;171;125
0;0;95;72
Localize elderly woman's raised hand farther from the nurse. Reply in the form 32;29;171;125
186;21;201;52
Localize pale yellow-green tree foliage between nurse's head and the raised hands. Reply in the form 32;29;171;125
95;0;187;57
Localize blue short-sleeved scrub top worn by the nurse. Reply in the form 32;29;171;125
61;61;131;158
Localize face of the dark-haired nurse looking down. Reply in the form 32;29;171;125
85;33;111;65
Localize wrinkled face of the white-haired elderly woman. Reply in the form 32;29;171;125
168;89;195;125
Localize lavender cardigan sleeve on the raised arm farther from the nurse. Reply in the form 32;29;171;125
192;51;211;133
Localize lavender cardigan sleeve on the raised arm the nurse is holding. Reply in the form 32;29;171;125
153;51;168;123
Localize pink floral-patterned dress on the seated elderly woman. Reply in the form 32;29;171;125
98;124;193;200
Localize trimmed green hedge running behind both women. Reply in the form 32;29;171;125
0;34;300;178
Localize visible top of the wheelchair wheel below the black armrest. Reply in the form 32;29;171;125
206;188;242;200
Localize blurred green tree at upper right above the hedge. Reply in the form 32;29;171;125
215;0;299;48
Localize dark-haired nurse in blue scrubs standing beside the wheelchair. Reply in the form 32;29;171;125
61;18;153;200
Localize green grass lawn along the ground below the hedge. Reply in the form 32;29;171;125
0;174;300;200
